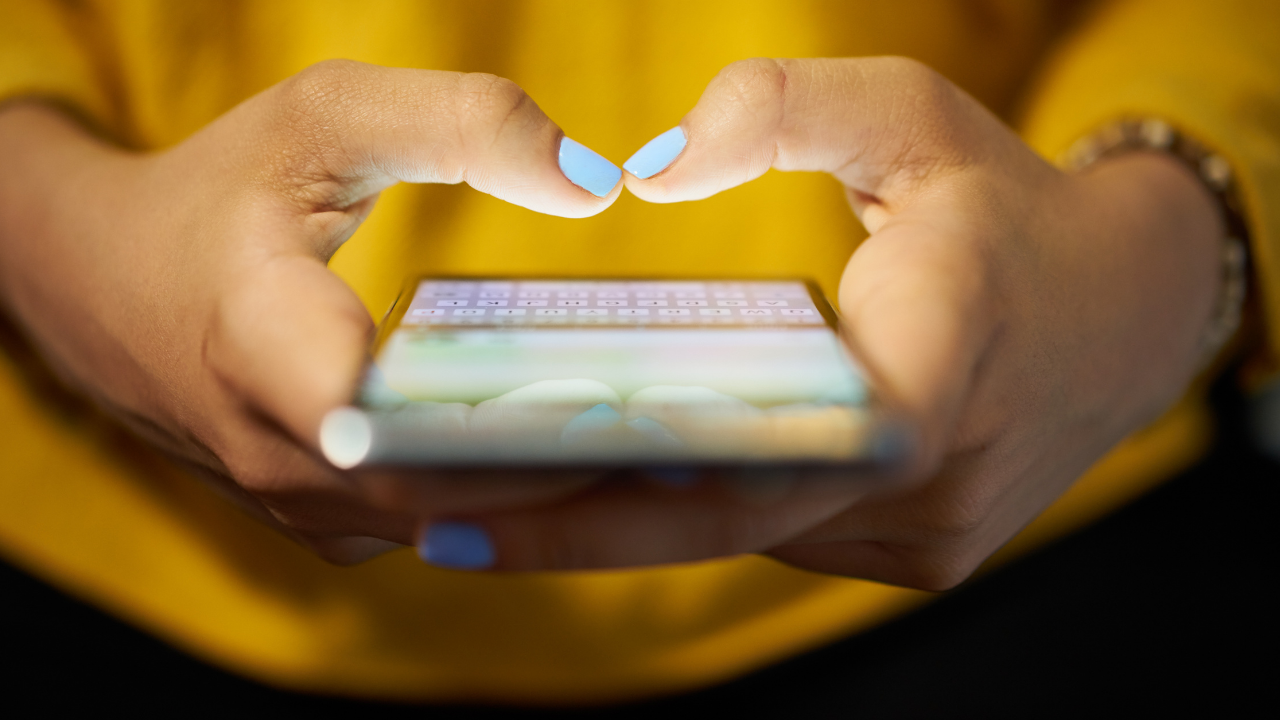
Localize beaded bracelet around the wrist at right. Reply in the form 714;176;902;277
1059;118;1249;369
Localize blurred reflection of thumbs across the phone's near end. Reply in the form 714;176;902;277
320;369;896;469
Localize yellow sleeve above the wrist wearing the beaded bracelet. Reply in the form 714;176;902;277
1021;0;1280;370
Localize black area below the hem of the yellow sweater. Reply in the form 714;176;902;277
0;374;1280;719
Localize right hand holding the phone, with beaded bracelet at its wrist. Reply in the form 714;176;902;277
455;59;1222;589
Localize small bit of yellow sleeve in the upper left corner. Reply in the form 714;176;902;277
0;0;113;127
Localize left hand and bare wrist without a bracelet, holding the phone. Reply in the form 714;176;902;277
0;61;621;562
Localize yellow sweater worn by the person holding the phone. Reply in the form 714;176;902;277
0;0;1280;702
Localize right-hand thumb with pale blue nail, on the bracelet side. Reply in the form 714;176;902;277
623;58;986;211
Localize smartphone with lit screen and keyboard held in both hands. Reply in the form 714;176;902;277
320;277;906;469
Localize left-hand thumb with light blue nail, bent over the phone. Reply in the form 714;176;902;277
241;60;622;218
